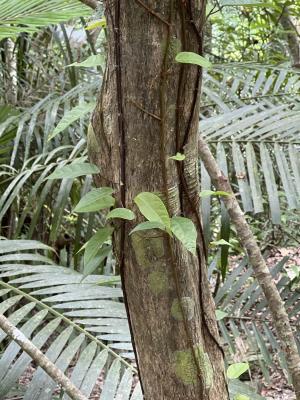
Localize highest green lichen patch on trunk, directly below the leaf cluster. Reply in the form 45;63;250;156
131;230;165;268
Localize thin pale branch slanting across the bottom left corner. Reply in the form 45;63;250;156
0;314;88;400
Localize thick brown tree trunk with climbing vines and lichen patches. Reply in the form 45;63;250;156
88;0;228;400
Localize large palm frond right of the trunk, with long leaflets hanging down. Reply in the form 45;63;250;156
200;67;300;225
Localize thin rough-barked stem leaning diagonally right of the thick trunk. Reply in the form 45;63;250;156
199;137;300;400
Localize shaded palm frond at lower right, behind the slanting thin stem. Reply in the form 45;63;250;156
210;257;300;381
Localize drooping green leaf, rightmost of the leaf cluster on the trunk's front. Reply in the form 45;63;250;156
171;217;197;254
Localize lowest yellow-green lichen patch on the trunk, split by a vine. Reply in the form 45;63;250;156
173;344;213;390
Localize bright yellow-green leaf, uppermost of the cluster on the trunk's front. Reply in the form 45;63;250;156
134;192;171;233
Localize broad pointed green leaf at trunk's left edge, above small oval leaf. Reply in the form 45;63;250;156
74;187;115;213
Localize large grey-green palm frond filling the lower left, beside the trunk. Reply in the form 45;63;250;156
0;240;142;400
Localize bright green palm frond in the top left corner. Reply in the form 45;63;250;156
0;0;91;40
